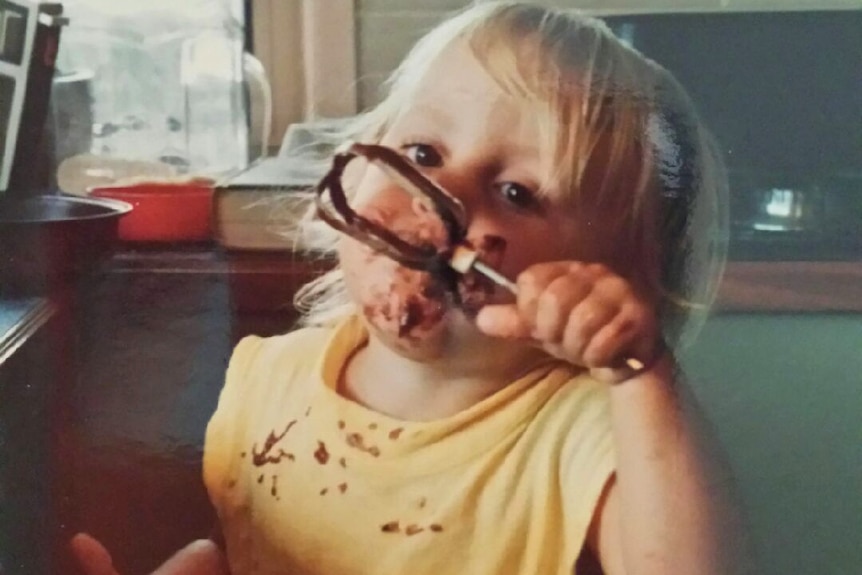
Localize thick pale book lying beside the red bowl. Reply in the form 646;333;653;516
213;156;326;251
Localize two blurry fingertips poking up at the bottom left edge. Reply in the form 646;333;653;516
69;533;230;575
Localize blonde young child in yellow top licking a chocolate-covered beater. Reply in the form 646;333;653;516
74;2;748;575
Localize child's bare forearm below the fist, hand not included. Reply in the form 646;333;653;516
590;356;742;575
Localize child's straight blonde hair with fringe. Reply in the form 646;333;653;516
295;1;726;343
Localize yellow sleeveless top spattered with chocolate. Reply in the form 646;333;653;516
204;318;614;575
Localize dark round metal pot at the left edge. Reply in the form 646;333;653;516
0;195;132;295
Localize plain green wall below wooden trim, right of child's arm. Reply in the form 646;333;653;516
683;314;862;575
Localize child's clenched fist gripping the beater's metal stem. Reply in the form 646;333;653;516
476;262;662;383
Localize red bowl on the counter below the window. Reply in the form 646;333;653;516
90;181;214;242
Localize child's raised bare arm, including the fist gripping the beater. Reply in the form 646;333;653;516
477;262;752;575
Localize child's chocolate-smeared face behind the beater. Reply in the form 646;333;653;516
339;40;583;357
